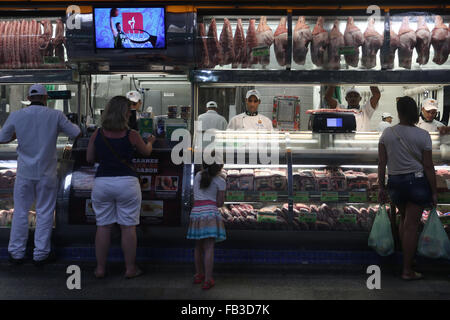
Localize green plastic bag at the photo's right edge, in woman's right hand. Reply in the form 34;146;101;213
417;208;450;259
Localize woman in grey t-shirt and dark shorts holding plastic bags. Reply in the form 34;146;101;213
378;97;437;280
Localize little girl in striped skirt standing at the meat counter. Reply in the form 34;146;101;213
187;163;226;290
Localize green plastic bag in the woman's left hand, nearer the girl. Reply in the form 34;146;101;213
369;205;395;256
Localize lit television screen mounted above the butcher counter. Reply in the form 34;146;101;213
94;8;166;49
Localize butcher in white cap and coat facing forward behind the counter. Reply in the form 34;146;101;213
227;90;273;130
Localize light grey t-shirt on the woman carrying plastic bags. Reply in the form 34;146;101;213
380;124;432;175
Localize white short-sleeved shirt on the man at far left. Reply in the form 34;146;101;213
0;105;80;180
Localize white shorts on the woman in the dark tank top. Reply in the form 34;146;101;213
91;176;142;226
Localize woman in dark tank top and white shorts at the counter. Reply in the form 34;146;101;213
87;96;154;278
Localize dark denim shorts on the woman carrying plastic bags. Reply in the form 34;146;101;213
387;173;432;207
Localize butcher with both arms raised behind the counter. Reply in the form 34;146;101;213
325;86;381;131
